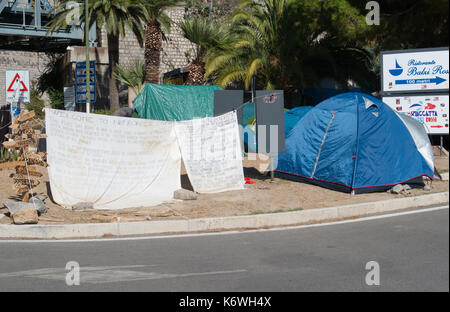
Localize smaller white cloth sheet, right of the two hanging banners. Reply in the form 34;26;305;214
175;112;245;193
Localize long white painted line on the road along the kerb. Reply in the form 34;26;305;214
0;206;449;244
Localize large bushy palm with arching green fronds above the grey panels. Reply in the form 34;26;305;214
205;0;372;93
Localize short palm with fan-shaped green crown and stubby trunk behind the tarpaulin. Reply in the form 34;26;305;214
179;17;228;85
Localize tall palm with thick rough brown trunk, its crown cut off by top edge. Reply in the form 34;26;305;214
144;0;180;83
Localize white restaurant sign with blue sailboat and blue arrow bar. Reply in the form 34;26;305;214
381;48;449;93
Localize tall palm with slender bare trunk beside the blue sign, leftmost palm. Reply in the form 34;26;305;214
47;0;148;110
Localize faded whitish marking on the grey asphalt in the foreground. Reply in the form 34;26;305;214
0;265;247;284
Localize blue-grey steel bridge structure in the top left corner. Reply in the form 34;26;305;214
0;0;96;52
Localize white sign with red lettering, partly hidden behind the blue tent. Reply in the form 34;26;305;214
383;95;449;134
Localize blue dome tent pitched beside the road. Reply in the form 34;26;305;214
275;93;434;193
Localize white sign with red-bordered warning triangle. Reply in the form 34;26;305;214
6;70;30;103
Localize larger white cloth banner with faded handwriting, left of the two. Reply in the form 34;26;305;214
45;109;181;209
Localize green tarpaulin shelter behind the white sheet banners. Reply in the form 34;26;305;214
133;83;222;121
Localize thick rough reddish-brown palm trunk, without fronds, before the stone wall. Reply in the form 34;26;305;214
144;21;162;83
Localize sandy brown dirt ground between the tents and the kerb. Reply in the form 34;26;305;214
0;151;449;224
